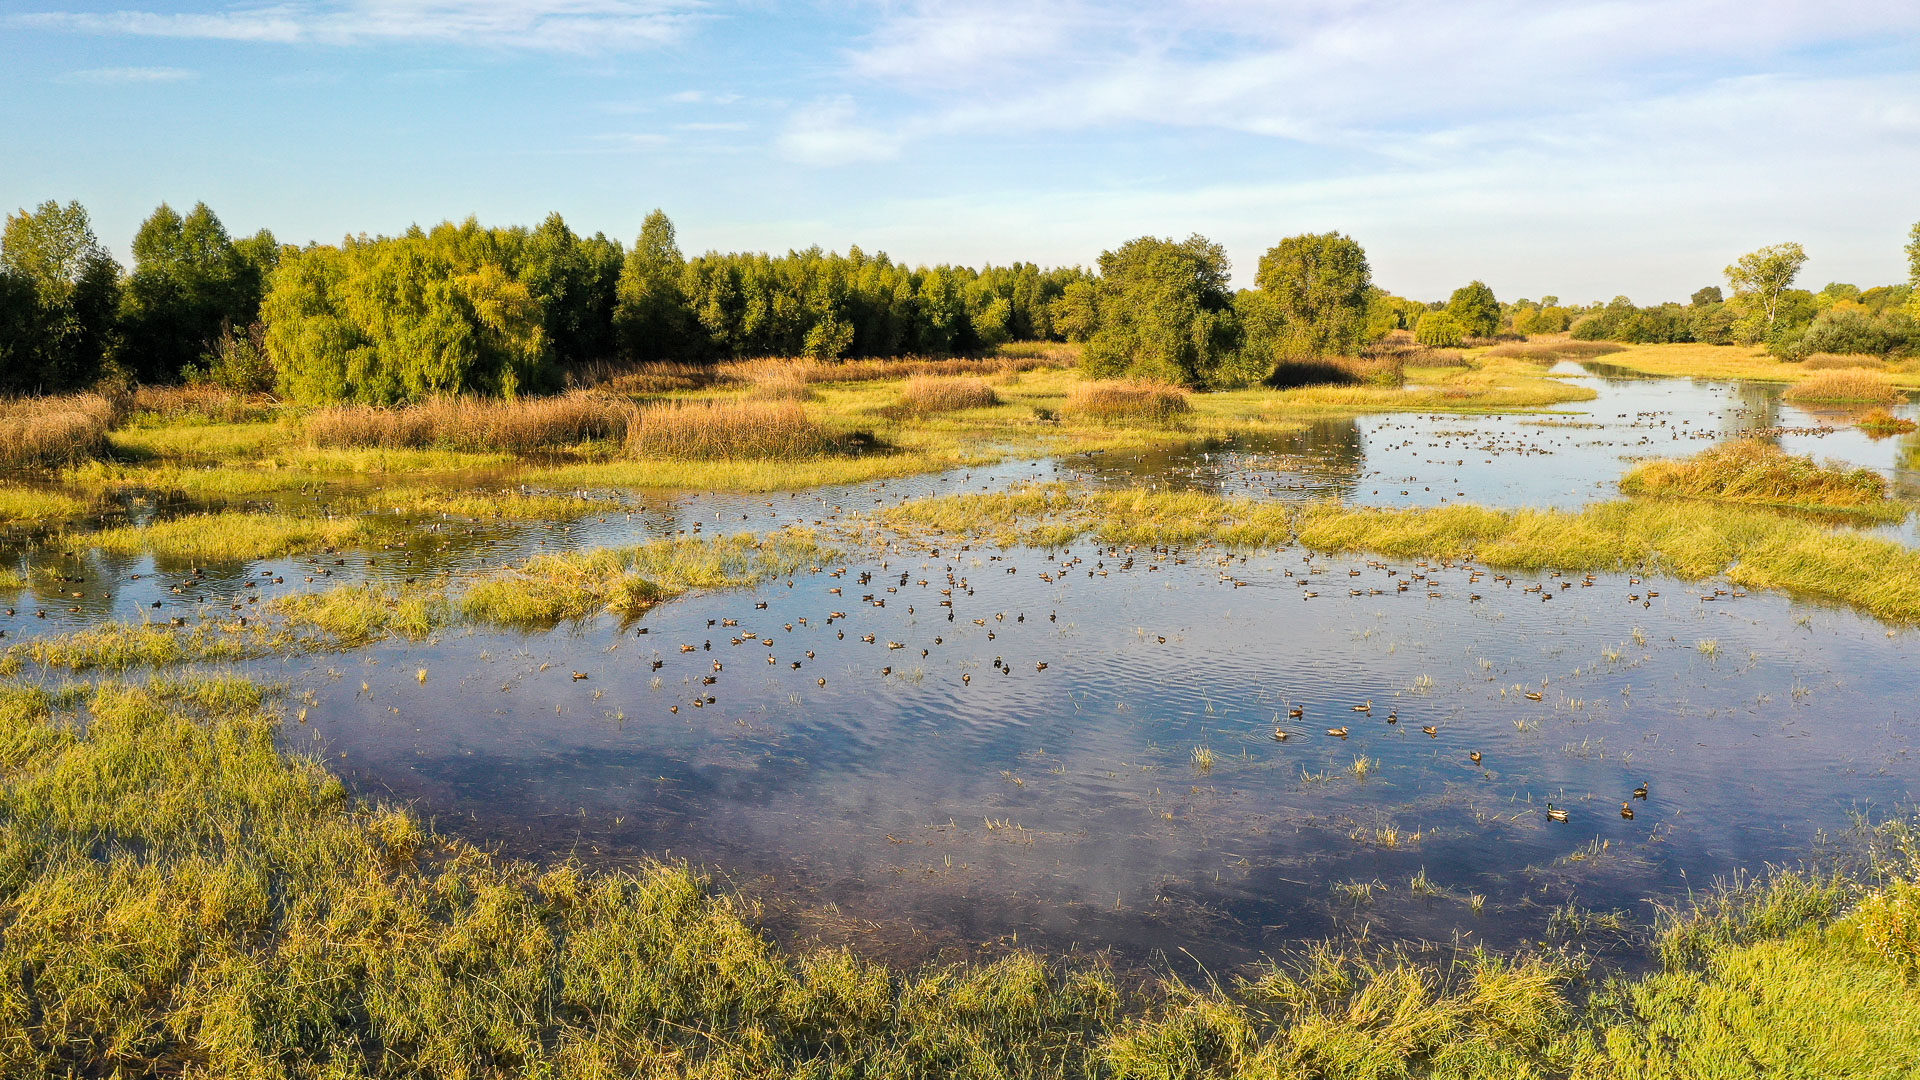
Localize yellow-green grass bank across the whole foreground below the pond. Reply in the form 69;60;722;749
0;678;1920;1080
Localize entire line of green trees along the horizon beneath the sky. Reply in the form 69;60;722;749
15;202;1920;404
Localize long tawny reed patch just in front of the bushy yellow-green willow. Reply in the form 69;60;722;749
307;390;636;454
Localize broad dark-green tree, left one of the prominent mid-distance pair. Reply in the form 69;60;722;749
1085;234;1238;386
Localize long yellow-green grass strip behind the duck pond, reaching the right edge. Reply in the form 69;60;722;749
887;484;1920;623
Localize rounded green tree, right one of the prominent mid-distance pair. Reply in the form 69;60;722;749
1246;233;1373;359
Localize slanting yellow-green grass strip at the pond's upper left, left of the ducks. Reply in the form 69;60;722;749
459;528;835;626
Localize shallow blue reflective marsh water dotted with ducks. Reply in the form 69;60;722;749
6;361;1920;967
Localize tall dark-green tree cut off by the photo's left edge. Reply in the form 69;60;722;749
0;200;119;392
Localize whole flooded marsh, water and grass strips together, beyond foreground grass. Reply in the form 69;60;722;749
0;355;1920;1074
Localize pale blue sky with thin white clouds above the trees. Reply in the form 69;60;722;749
0;0;1920;304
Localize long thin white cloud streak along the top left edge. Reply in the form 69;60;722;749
11;0;701;52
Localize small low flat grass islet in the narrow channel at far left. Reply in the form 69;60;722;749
72;511;376;563
